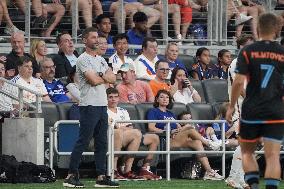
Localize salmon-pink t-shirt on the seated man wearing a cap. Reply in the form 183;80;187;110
116;80;154;104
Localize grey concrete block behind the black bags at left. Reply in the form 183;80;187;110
2;118;44;165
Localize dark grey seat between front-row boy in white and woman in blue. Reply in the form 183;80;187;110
135;103;153;133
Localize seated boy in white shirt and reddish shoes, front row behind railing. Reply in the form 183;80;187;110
106;88;161;180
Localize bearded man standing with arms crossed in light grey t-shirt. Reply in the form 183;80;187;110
63;27;119;188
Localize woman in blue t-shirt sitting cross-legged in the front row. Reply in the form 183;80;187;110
147;90;223;180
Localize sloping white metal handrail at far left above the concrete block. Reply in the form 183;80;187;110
0;77;42;118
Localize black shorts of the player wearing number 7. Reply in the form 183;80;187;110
239;121;284;143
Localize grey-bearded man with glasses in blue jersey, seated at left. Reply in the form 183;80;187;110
40;58;71;103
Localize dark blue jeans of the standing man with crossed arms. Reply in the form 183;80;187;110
69;106;108;175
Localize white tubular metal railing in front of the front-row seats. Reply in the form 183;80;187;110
49;120;284;181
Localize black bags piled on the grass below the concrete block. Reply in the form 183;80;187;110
0;155;56;183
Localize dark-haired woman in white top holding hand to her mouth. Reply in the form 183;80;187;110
170;67;201;104
